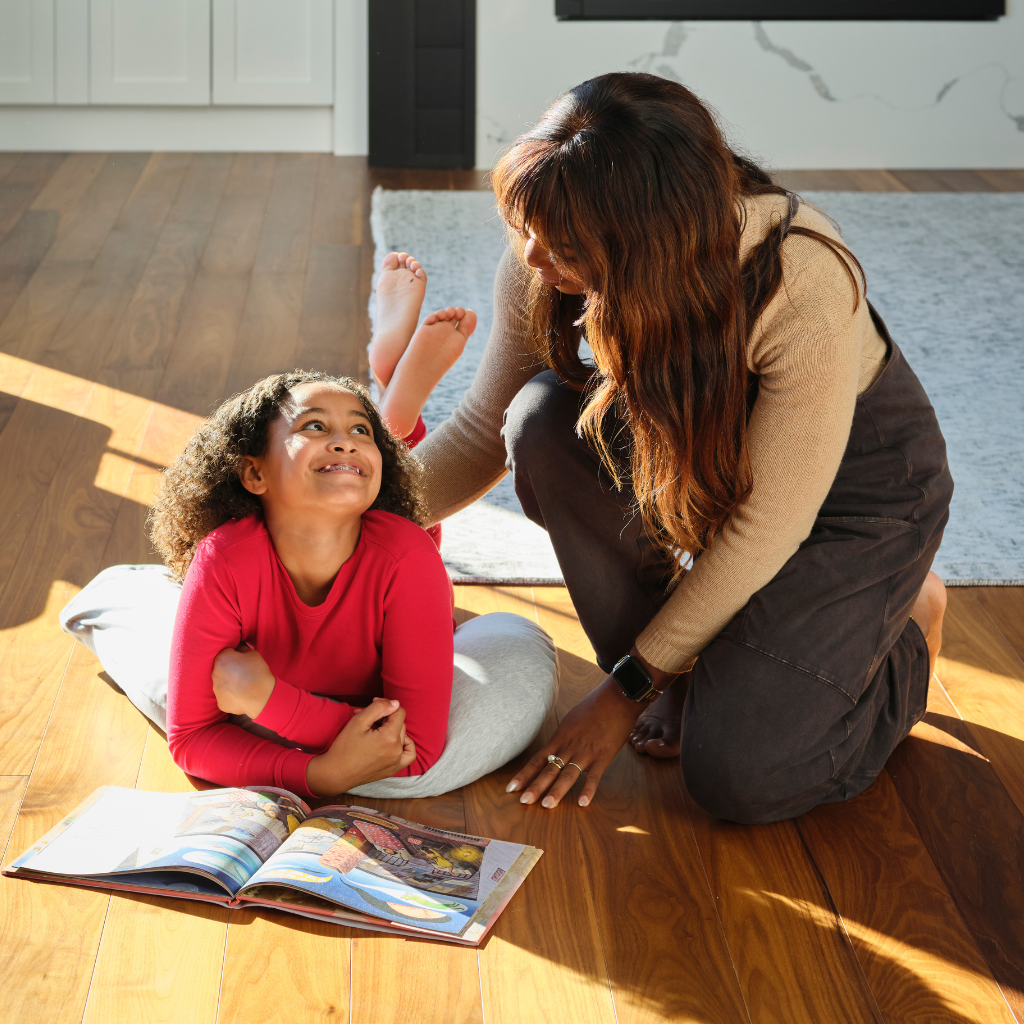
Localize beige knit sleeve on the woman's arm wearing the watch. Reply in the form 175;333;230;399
637;237;876;672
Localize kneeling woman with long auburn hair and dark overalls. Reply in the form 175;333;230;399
409;74;952;822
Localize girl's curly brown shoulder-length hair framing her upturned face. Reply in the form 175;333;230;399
147;370;423;580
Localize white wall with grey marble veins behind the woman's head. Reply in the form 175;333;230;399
476;0;1024;168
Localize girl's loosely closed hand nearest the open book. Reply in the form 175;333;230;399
306;697;416;797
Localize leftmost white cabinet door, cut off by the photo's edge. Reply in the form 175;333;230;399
0;0;53;103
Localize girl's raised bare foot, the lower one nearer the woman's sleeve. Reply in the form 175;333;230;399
380;306;476;437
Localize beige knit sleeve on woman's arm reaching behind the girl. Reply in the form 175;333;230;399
416;243;546;523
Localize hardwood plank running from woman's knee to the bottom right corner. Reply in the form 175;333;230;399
796;772;1015;1024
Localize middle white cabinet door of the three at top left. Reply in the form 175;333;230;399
89;0;210;106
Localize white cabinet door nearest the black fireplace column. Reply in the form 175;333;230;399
213;0;334;106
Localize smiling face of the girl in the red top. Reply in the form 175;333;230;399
241;383;381;515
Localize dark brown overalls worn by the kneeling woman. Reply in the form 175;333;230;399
503;309;953;823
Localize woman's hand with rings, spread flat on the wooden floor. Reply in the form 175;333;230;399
506;676;647;807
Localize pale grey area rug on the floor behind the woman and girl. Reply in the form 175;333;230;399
371;188;1024;586
